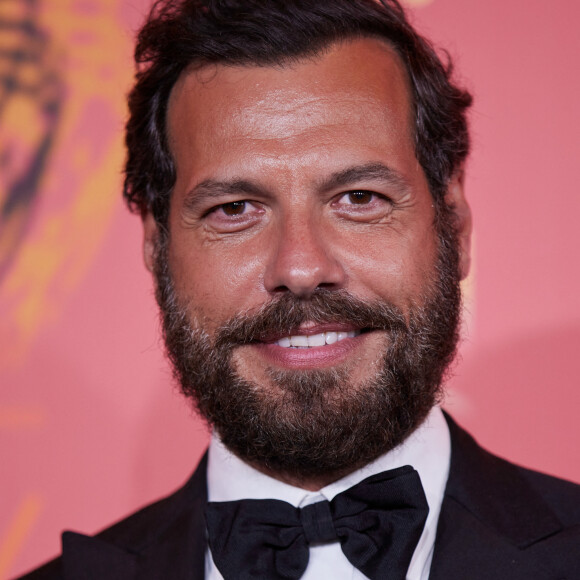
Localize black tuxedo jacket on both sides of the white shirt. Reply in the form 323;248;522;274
18;418;580;580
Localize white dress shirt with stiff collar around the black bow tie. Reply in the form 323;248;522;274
205;407;451;580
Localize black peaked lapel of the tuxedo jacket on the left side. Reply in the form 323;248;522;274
62;456;207;580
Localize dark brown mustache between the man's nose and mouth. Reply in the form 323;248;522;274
215;289;408;347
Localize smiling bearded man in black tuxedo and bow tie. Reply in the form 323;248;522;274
21;0;580;580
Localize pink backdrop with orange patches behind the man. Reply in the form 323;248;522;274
0;0;580;578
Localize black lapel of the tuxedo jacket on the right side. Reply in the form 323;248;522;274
430;416;562;580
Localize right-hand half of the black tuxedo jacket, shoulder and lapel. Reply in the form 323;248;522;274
432;416;580;580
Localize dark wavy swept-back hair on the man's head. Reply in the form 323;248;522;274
123;0;471;225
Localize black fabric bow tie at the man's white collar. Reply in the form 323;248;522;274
206;465;429;580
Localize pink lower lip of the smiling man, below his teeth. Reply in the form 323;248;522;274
251;333;368;369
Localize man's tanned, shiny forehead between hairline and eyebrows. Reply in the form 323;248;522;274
168;38;412;163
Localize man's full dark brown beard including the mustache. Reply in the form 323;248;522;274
155;208;460;479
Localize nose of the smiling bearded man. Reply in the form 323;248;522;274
264;215;346;297
